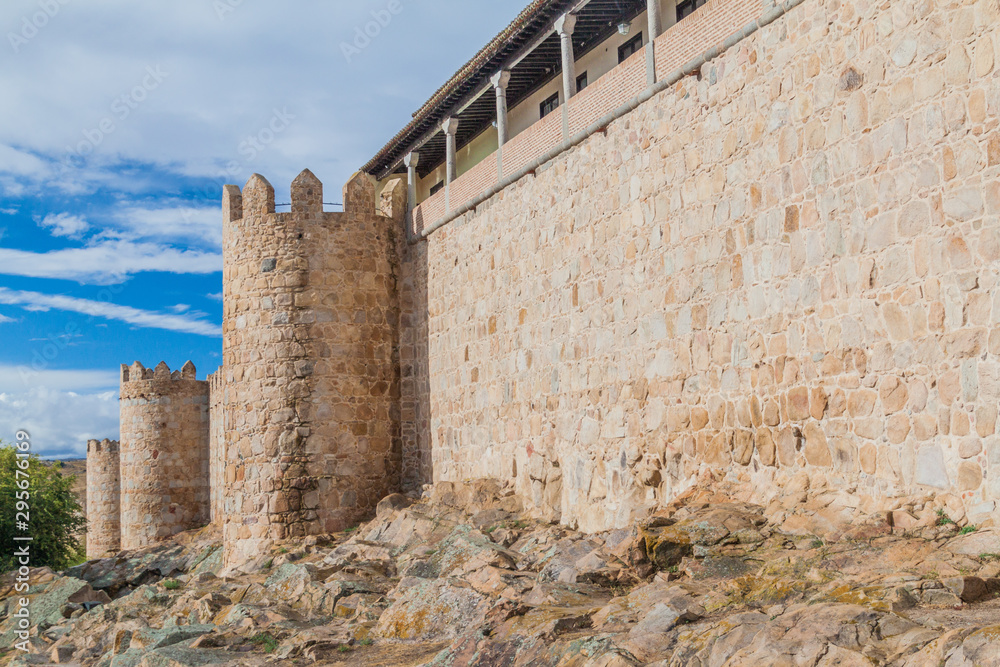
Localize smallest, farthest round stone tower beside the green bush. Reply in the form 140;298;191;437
87;440;121;560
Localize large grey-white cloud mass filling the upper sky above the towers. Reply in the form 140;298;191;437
0;0;524;201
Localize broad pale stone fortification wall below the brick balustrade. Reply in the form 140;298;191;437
401;0;1000;530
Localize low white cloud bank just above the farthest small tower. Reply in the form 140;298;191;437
0;387;119;457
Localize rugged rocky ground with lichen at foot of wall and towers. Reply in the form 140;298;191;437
0;474;1000;667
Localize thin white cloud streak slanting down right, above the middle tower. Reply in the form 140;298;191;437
0;287;222;336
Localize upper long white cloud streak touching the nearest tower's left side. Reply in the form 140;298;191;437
0;240;222;285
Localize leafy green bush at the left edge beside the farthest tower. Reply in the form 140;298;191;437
0;443;87;572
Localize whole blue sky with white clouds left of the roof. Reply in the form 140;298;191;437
0;0;525;456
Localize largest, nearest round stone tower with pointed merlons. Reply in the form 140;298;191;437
222;170;401;564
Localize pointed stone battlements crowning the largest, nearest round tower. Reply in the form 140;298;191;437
222;169;380;224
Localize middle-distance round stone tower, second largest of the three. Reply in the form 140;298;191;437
121;361;210;549
